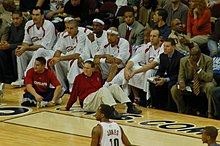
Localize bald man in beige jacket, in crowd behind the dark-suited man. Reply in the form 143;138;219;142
168;18;190;55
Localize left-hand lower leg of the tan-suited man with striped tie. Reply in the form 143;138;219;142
171;85;185;113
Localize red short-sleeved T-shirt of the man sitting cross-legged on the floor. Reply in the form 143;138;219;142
25;68;60;93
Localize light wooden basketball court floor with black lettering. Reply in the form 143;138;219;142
0;85;220;146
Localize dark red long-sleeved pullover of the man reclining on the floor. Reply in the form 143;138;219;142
66;72;102;110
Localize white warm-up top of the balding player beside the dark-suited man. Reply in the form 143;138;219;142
130;42;164;65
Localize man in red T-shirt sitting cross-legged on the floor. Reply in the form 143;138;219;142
21;57;62;107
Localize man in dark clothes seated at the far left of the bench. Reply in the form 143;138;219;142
0;11;26;83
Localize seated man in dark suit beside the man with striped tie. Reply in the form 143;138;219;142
150;38;184;111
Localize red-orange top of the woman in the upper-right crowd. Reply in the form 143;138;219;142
187;9;211;37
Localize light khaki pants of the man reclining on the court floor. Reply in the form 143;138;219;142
83;84;131;112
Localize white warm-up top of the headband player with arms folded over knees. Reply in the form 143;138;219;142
96;38;130;65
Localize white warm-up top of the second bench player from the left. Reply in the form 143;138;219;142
54;30;87;55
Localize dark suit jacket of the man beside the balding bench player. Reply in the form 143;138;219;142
156;50;184;88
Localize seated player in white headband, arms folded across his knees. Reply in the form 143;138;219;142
94;27;130;85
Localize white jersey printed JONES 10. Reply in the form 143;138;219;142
99;122;123;146
